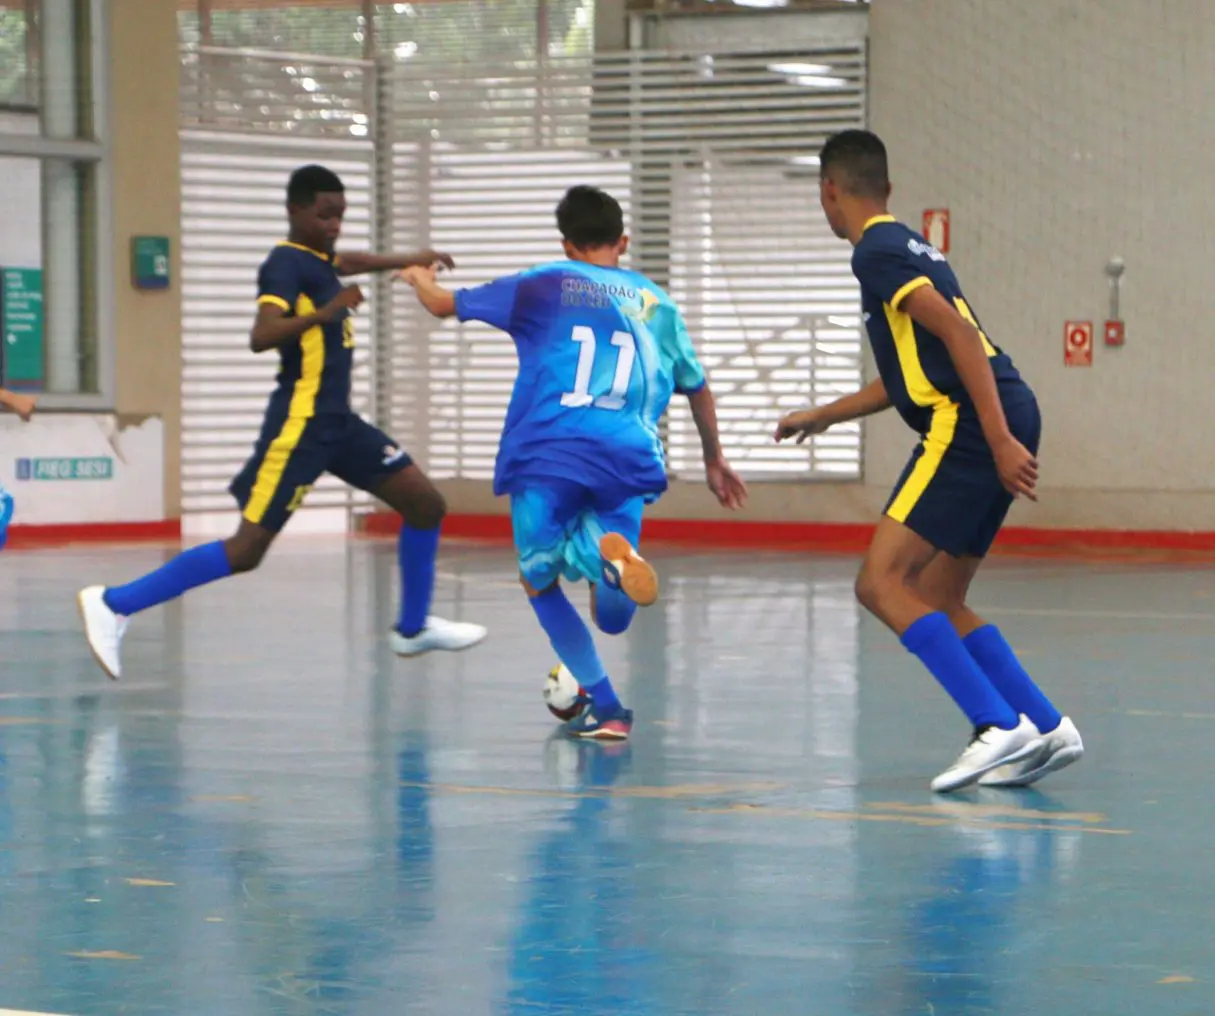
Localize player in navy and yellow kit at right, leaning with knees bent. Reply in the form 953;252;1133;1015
776;130;1084;792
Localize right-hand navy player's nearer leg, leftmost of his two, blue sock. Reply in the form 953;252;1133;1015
857;517;1042;792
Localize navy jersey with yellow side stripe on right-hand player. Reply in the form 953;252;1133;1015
852;215;1023;434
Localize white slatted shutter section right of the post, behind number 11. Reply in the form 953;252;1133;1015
385;49;864;479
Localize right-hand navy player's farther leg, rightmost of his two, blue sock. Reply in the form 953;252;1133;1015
915;554;1084;786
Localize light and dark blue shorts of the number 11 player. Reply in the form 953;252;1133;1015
510;479;645;589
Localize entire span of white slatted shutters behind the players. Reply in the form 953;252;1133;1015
182;30;865;512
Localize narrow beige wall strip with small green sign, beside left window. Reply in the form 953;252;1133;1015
108;0;181;517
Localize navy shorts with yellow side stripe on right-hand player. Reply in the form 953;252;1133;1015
886;389;1042;558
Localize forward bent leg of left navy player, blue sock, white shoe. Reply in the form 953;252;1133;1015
372;464;487;656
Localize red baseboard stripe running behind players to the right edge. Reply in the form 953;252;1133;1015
363;514;1215;553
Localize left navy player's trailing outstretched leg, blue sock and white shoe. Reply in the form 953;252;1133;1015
77;519;275;681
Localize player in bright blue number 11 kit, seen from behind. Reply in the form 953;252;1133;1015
402;187;746;740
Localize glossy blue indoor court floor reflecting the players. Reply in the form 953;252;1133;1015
0;537;1215;1016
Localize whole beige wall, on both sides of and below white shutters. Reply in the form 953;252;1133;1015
109;0;1215;529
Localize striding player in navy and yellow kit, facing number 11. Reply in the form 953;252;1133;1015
79;165;486;678
